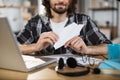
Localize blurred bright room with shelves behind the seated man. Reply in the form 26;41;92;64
0;0;120;43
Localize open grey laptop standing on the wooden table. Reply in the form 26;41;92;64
0;17;56;72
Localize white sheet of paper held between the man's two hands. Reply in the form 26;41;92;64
54;23;84;49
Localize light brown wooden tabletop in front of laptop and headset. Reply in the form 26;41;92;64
0;55;120;80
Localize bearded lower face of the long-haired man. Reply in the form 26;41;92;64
50;0;71;14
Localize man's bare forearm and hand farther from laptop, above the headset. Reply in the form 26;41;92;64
64;36;108;55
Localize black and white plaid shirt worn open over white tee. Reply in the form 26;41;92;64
17;14;111;55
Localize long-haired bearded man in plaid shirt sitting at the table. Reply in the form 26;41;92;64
17;0;111;54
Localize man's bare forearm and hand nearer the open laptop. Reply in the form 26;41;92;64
19;31;58;54
